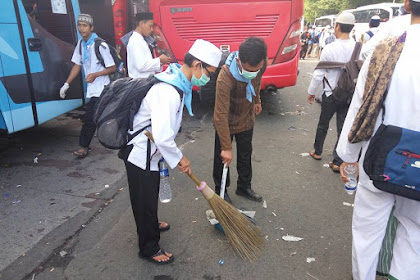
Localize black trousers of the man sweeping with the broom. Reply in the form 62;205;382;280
125;161;160;257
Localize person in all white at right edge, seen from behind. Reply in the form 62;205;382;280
337;0;420;280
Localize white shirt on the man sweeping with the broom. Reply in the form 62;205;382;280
128;83;184;171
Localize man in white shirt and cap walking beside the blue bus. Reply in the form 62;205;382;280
60;14;117;158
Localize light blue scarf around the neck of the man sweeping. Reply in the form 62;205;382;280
155;63;194;116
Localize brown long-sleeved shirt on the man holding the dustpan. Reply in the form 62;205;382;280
213;68;263;150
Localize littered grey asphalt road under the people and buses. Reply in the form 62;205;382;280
0;57;354;280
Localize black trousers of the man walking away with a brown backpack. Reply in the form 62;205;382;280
314;93;349;165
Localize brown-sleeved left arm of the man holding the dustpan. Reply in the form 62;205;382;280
213;68;234;164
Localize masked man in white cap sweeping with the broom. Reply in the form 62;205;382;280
123;40;222;264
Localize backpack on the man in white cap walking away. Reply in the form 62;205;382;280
315;42;363;105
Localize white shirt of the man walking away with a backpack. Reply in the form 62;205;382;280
308;39;356;97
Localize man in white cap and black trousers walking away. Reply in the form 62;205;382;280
307;13;356;173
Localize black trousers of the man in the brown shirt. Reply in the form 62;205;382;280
213;128;254;194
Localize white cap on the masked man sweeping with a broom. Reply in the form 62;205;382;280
188;39;222;67
